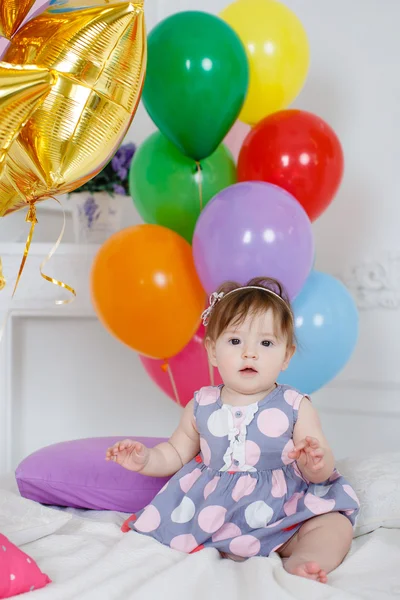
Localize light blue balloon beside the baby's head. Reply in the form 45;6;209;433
279;271;358;394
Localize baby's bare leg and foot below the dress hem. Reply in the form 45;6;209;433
278;512;353;583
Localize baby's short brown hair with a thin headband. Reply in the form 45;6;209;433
206;277;295;346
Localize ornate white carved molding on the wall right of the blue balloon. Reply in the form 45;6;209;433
342;253;400;310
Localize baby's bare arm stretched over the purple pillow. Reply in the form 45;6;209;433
106;400;200;477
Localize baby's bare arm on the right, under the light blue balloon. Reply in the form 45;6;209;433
289;398;335;483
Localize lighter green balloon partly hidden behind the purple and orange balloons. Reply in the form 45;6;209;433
129;132;236;243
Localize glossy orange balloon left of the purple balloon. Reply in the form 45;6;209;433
91;225;205;359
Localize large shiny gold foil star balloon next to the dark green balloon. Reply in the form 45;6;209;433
0;0;146;216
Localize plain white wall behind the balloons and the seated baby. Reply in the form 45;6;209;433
0;0;400;466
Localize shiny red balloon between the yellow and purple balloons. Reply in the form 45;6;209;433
238;110;344;221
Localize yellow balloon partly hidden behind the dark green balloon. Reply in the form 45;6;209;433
220;0;310;125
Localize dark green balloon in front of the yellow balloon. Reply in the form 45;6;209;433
142;11;249;160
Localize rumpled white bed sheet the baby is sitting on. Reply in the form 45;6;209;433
0;479;400;600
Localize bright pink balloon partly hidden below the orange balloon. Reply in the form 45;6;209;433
139;325;222;406
